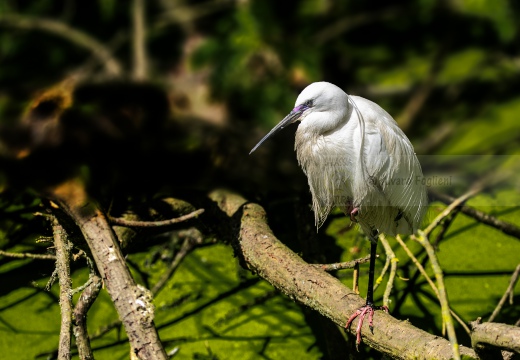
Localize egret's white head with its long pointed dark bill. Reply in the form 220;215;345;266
249;81;348;154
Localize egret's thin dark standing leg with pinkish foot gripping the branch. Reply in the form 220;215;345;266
345;236;388;348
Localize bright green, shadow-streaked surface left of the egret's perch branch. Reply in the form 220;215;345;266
0;244;321;359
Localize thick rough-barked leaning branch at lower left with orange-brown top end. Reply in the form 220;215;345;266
50;180;166;359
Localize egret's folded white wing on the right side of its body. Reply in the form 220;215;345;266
353;97;426;234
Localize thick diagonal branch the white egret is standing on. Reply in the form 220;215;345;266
210;191;476;359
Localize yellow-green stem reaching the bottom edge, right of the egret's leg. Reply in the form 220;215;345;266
411;231;458;360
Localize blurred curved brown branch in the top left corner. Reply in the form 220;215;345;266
0;13;122;76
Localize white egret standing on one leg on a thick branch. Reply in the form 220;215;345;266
250;82;427;344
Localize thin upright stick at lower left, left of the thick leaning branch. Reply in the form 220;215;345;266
52;218;72;359
